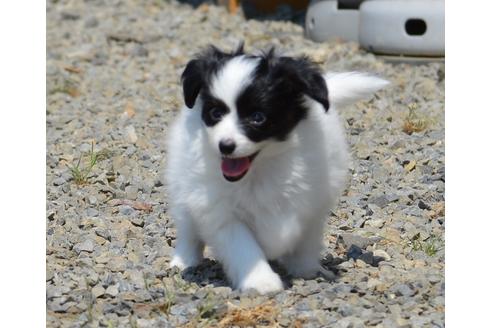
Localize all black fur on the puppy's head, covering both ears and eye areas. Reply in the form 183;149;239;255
181;44;329;142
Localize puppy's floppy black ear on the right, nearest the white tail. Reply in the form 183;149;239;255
270;57;330;111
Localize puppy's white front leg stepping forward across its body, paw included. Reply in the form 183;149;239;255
211;221;283;294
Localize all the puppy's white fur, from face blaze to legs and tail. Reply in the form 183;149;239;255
166;65;386;293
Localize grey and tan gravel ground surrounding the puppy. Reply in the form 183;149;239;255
46;0;445;327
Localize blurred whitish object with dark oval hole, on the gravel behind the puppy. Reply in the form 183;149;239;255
306;0;445;56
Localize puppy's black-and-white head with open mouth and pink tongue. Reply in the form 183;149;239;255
182;46;329;181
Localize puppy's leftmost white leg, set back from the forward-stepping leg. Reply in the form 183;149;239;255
170;210;204;270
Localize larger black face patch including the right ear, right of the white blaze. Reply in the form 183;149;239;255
236;50;329;142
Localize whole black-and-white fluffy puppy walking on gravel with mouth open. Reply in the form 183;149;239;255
166;47;387;294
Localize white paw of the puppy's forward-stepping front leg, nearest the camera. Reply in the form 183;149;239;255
239;264;284;294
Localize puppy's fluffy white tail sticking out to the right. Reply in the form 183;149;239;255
324;72;390;108
